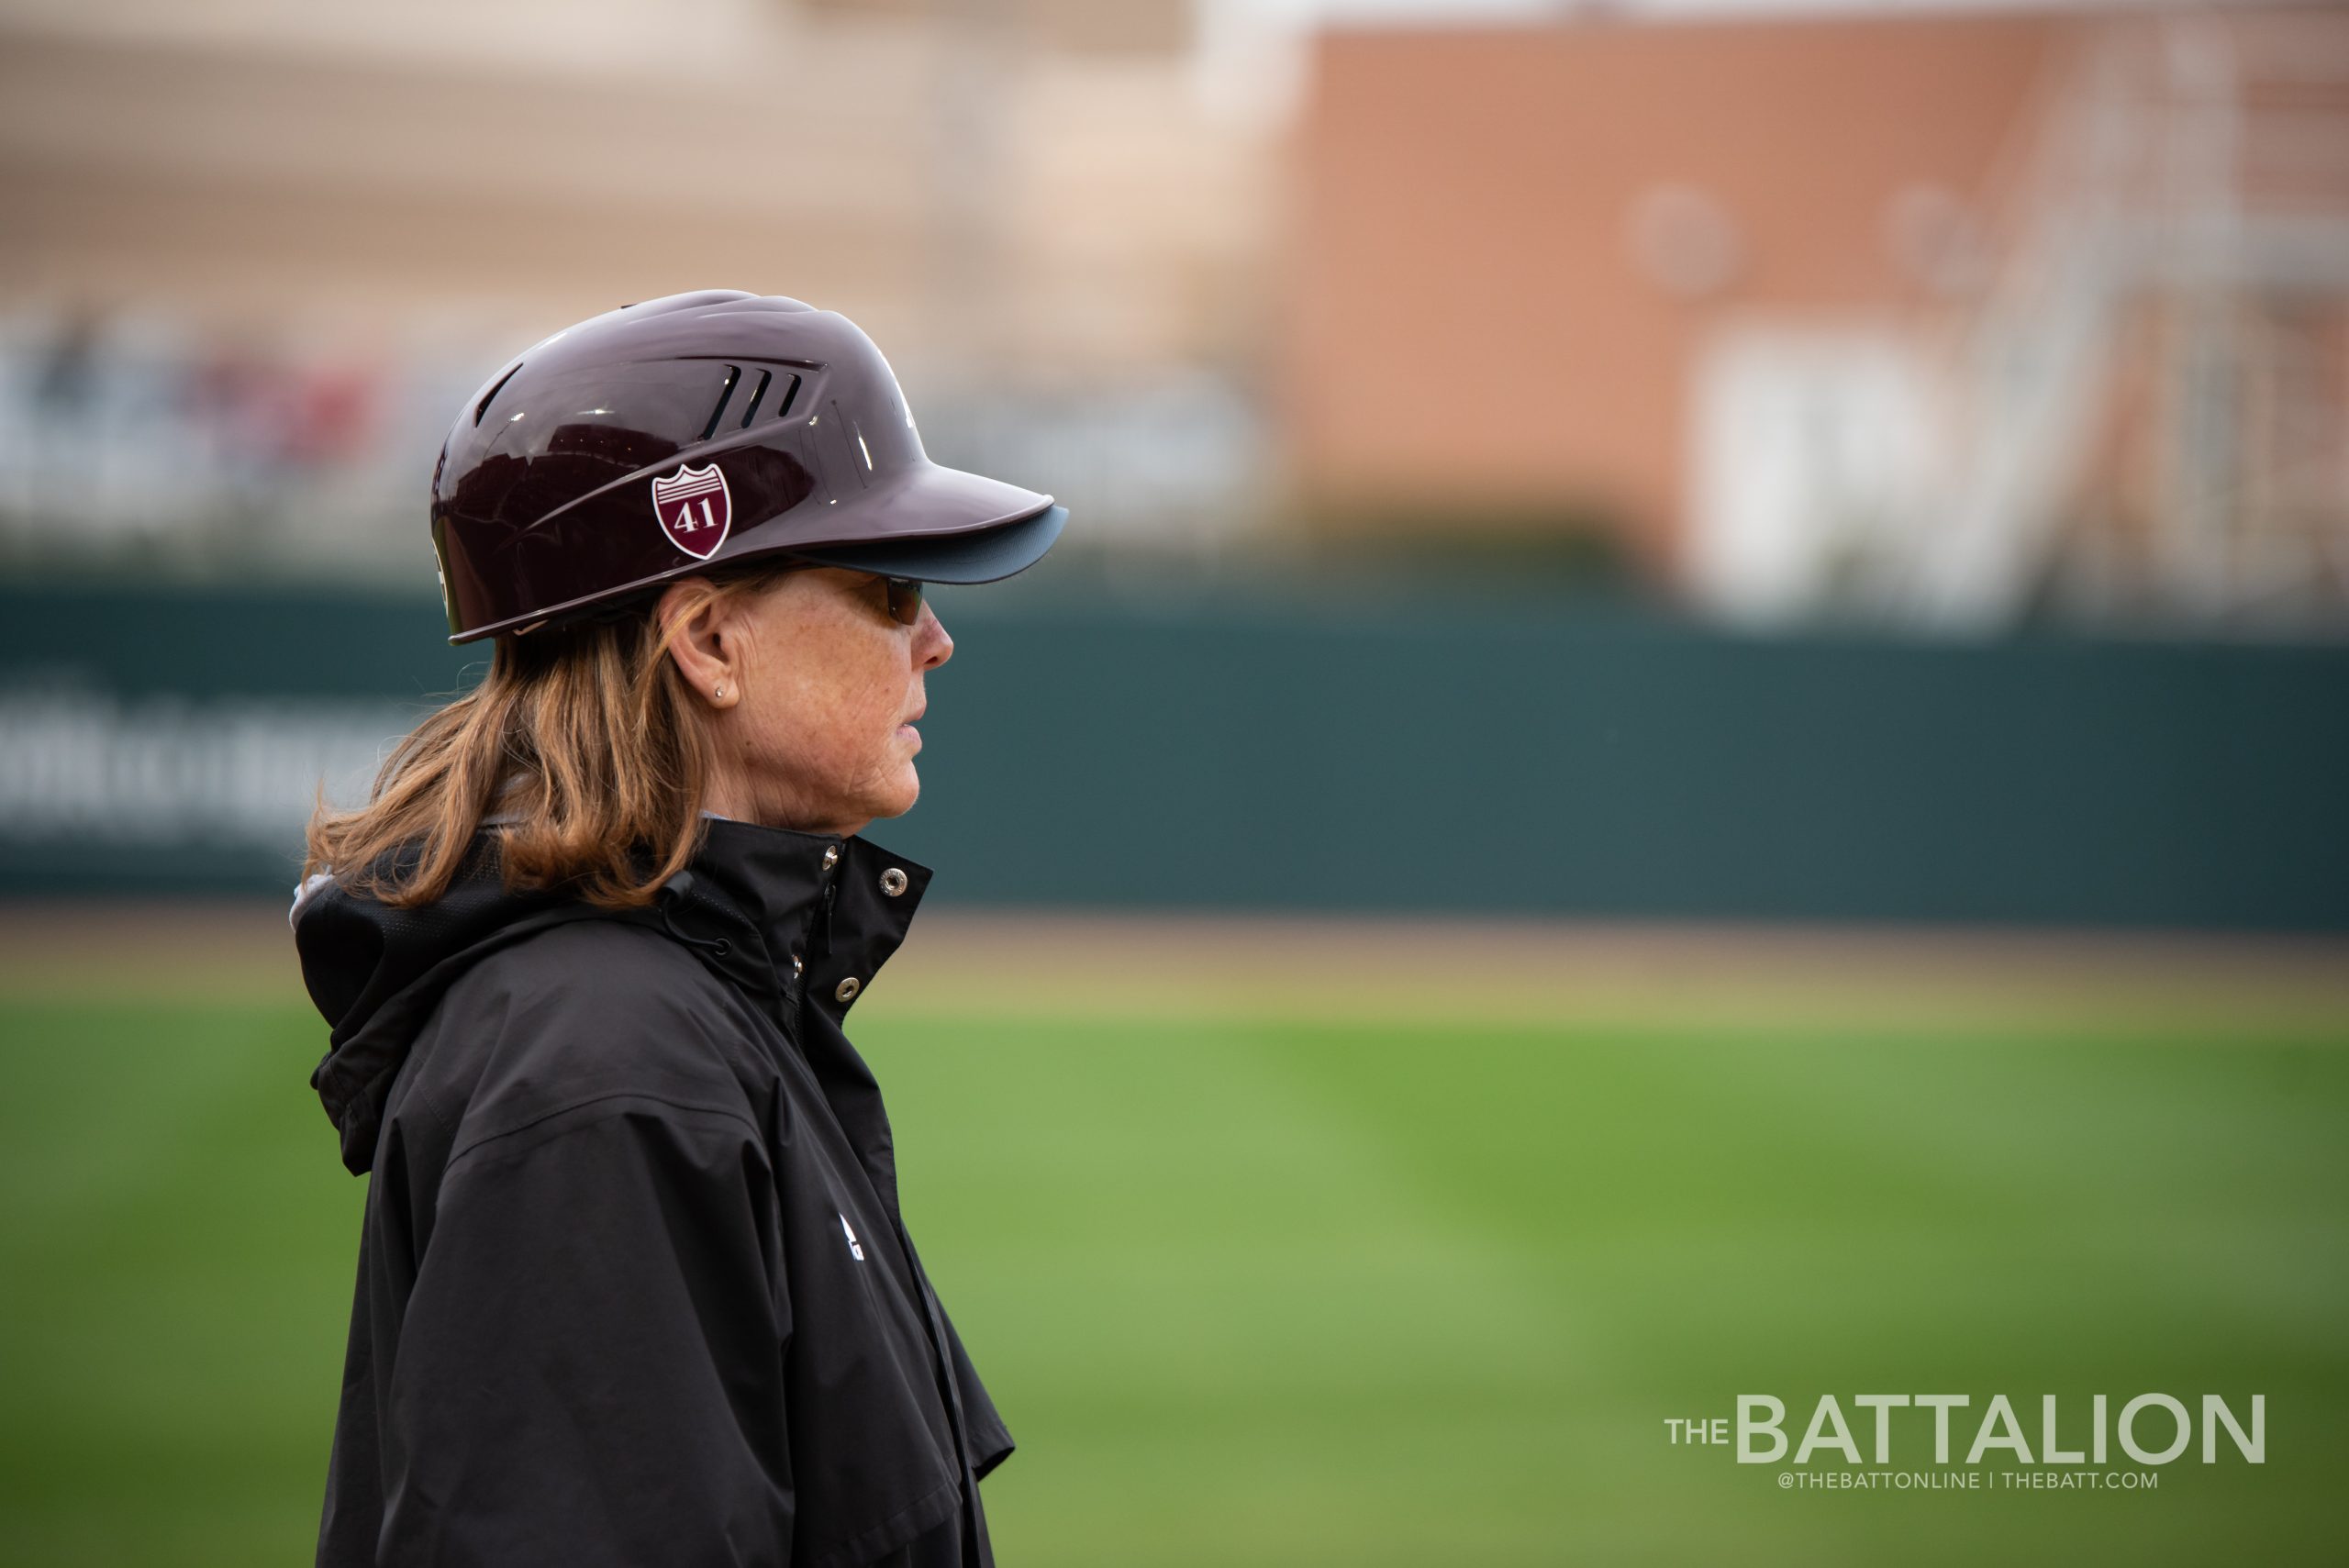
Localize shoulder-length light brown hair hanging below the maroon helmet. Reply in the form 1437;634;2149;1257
303;563;792;908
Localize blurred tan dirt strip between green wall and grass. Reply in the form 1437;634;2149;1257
0;901;2349;1035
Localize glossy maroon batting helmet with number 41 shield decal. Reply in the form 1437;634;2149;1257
432;289;1069;643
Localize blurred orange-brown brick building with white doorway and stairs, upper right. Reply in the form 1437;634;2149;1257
1283;9;2349;617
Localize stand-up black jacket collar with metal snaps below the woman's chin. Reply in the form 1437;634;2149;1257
662;817;930;1021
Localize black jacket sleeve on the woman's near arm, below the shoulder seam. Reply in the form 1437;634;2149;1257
378;1096;794;1568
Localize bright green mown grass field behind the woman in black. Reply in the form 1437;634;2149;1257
0;925;2349;1568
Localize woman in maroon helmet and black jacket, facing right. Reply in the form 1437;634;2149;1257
294;294;1064;1568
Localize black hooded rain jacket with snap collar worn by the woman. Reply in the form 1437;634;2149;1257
294;821;1012;1568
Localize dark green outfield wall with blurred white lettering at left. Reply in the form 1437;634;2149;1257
0;584;2349;929
